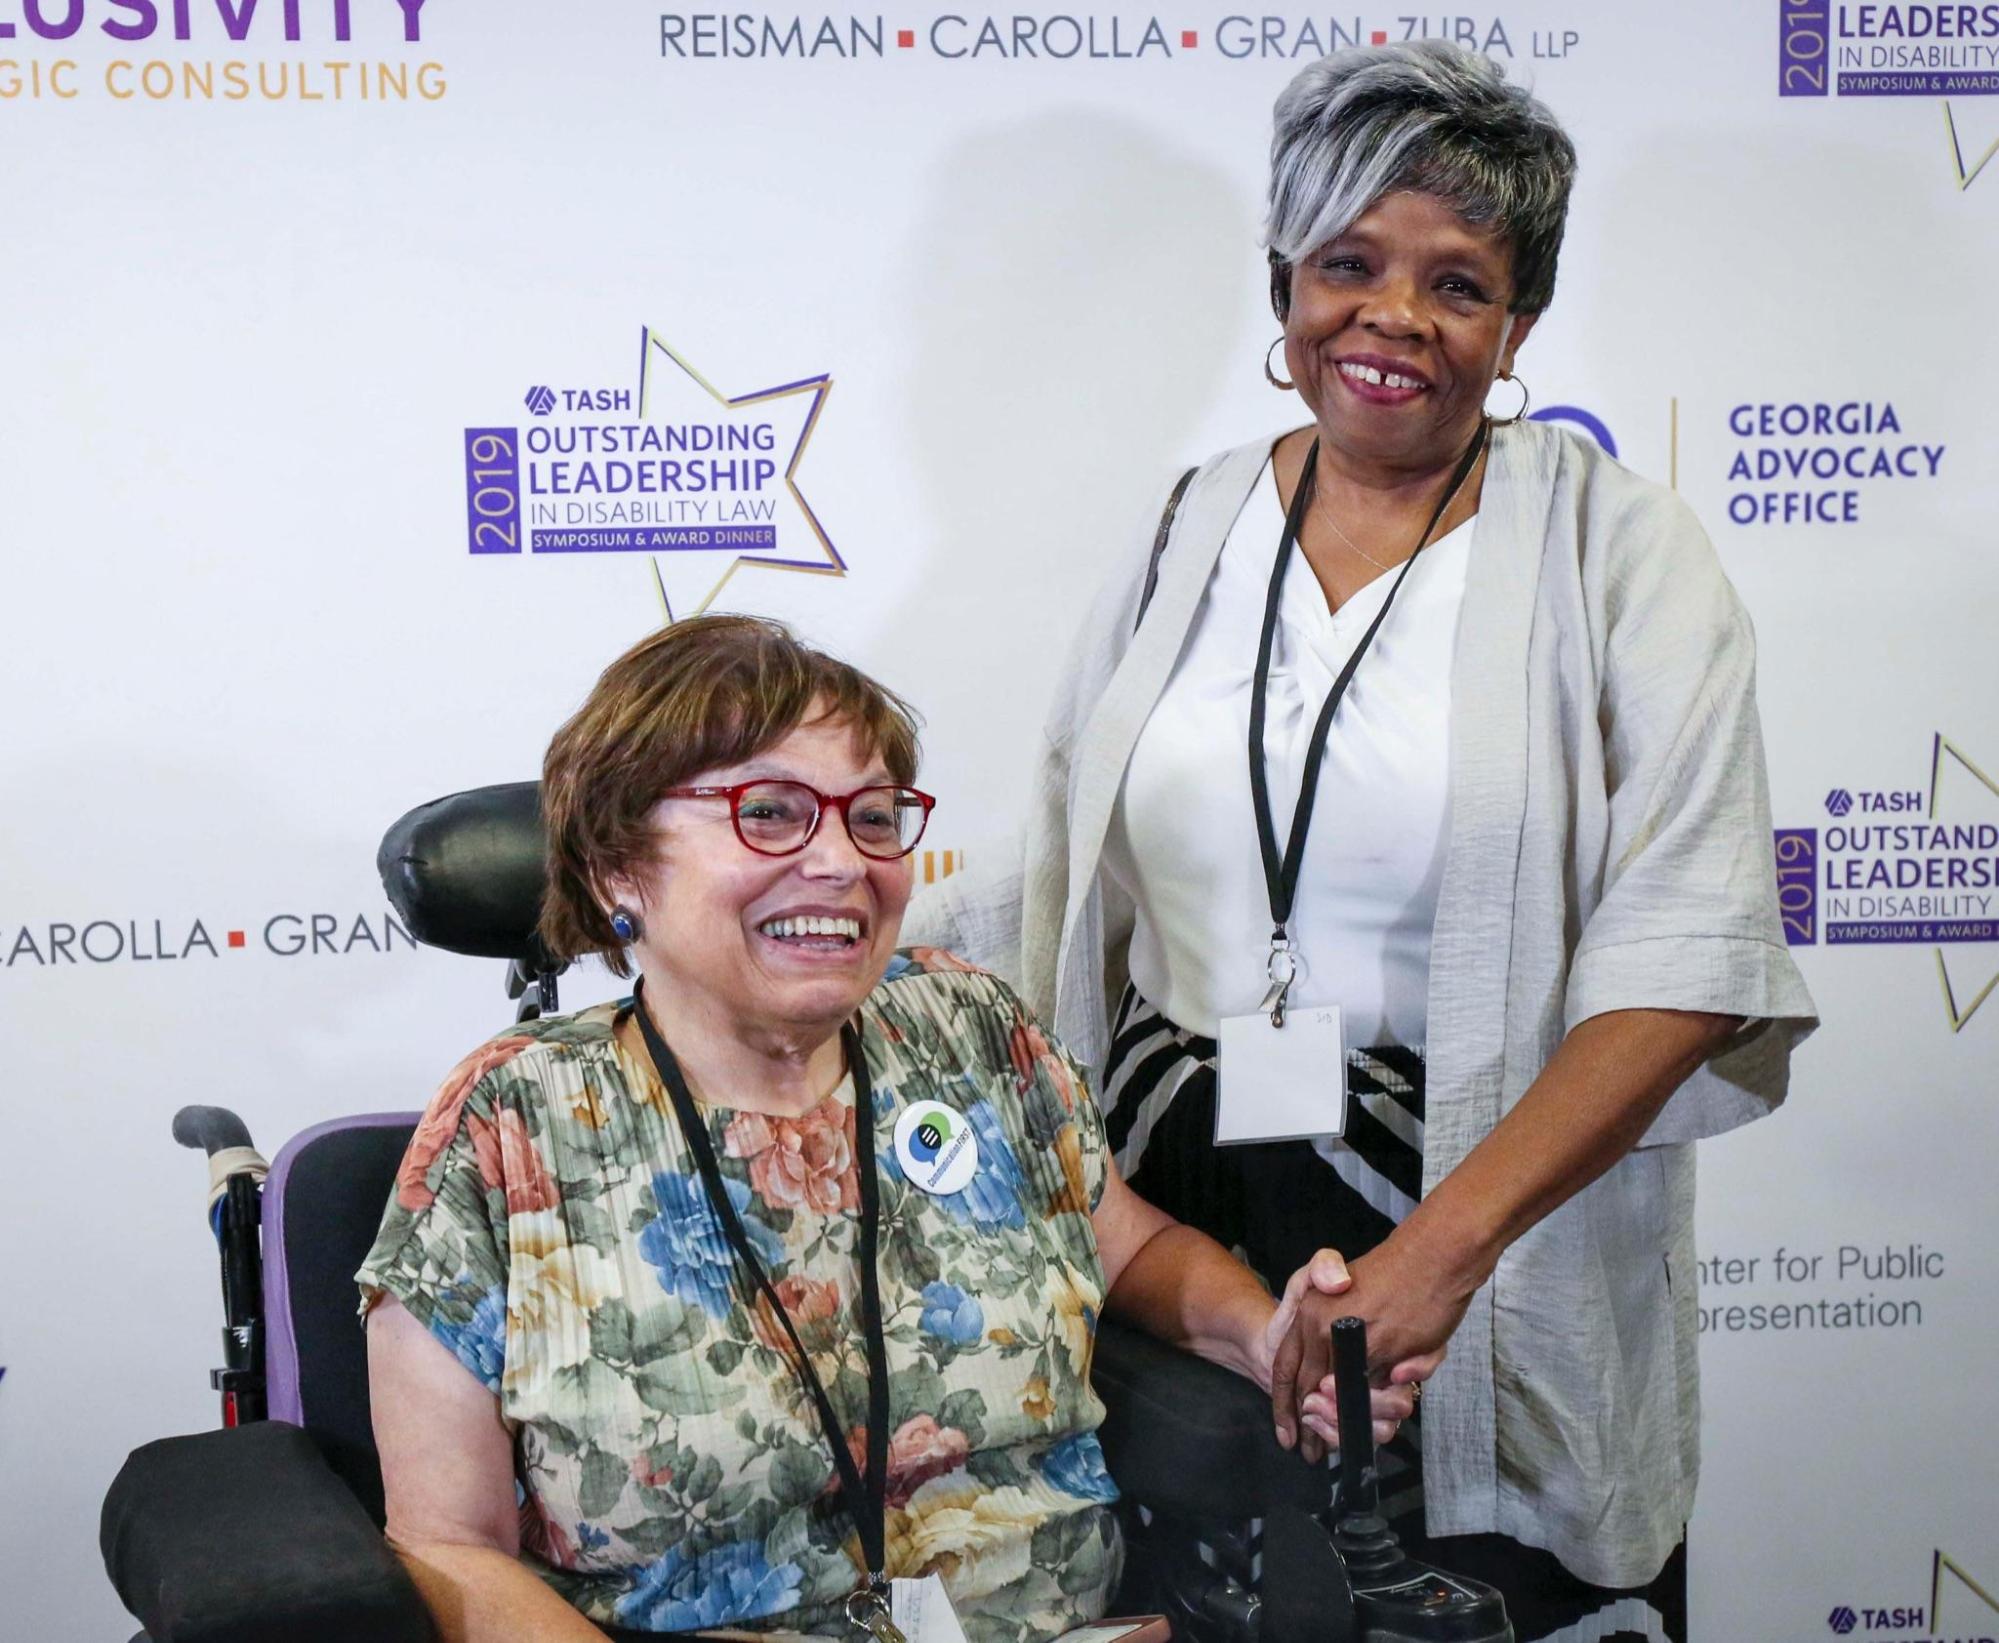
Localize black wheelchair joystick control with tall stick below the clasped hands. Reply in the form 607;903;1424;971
1263;1317;1513;1643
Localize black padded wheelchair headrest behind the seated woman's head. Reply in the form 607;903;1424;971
376;782;562;971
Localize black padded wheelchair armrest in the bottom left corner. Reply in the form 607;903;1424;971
98;1421;432;1643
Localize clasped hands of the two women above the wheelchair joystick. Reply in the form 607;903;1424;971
1263;1237;1469;1463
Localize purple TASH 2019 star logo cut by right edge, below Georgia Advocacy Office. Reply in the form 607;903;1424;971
1775;732;1999;1031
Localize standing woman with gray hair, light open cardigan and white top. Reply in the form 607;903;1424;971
912;42;1815;1643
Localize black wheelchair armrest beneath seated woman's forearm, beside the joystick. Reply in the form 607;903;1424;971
1089;1319;1333;1517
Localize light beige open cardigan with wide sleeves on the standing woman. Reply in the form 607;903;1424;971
906;422;1817;1585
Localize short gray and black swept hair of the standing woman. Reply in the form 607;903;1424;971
1263;40;1575;314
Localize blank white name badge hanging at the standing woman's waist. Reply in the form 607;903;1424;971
1215;1003;1347;1147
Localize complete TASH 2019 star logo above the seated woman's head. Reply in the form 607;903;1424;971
466;326;848;618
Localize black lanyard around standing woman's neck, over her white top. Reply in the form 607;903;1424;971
1249;420;1485;1027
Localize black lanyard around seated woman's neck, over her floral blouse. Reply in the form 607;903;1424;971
632;983;888;1593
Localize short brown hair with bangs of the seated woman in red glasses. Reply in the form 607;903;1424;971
542;616;918;975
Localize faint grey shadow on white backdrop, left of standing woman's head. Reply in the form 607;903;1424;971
892;108;1259;770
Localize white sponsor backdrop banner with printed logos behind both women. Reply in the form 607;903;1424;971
0;0;1999;1643
